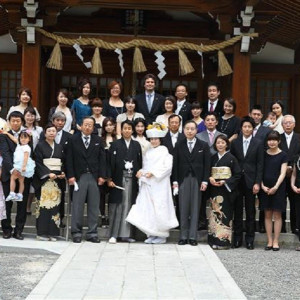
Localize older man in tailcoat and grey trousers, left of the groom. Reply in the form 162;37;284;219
66;117;106;243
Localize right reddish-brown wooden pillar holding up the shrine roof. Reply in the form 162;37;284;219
232;43;251;117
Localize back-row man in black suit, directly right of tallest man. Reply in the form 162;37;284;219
175;83;193;126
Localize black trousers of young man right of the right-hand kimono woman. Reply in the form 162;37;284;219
233;177;255;243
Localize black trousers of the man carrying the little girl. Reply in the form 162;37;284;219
1;178;31;232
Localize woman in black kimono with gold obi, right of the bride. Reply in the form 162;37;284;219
208;134;241;249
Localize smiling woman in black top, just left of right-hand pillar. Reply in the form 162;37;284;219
217;98;241;142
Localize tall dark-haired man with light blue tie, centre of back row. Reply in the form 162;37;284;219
135;74;165;124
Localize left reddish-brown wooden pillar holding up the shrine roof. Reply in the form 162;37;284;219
22;43;41;108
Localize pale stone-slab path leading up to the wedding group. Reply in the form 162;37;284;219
22;239;246;299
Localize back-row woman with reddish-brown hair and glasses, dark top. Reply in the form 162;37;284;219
103;80;125;120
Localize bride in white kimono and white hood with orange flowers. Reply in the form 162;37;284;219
126;123;178;244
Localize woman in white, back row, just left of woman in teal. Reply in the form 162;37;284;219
48;89;76;133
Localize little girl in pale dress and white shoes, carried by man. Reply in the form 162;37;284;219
6;131;35;201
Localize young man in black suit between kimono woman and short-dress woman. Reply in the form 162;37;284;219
230;116;264;250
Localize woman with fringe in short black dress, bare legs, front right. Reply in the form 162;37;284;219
259;130;288;251
